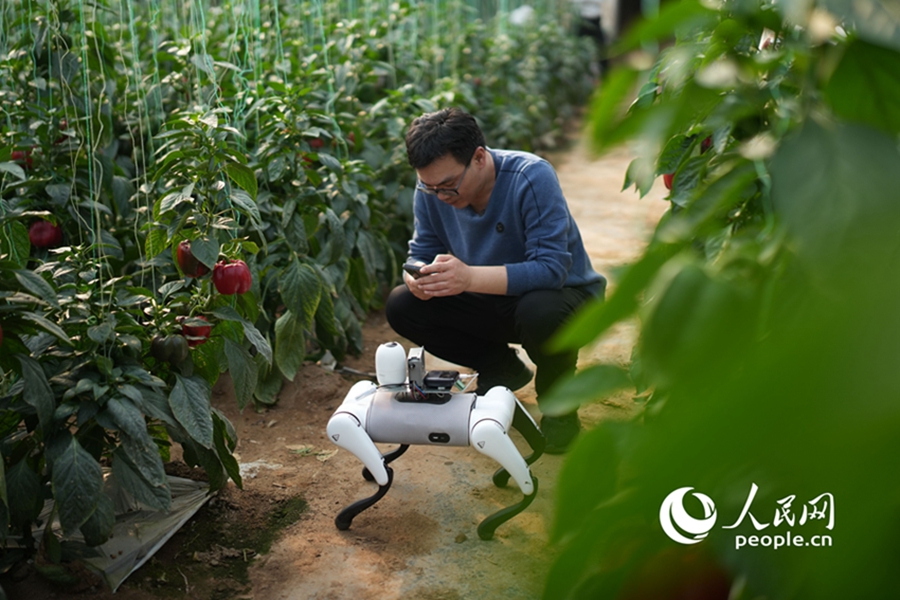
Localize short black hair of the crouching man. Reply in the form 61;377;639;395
406;107;485;169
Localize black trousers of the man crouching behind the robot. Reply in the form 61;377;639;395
385;285;602;404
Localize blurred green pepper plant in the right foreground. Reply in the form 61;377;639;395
544;0;900;599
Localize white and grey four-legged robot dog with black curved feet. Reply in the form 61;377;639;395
327;342;546;540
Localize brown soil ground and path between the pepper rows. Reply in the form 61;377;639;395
2;127;666;600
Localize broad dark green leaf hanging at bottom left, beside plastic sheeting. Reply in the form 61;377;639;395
50;432;103;533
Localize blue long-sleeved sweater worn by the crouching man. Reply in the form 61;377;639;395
409;150;605;296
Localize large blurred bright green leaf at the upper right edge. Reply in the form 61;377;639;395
823;40;900;135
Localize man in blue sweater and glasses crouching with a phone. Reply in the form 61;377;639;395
386;108;606;453
